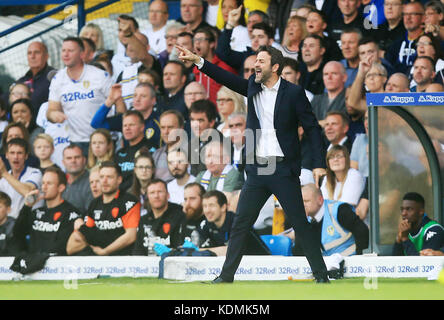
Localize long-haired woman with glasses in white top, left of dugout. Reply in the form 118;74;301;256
321;145;365;206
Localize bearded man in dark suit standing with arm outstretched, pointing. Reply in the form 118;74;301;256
176;46;328;283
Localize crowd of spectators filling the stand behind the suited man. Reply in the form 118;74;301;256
0;0;444;255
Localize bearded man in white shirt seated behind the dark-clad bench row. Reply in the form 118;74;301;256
167;149;196;205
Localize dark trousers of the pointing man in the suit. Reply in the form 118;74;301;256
220;170;327;281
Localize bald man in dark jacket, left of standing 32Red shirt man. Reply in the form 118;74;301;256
17;41;54;115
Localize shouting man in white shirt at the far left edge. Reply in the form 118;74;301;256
0;138;42;219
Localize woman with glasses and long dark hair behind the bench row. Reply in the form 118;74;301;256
129;147;155;215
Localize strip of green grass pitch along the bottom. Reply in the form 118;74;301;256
0;278;444;300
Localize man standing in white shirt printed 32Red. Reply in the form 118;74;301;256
46;37;112;154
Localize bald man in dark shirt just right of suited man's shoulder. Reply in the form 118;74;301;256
311;61;347;127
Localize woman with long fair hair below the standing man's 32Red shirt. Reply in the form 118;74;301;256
87;128;114;169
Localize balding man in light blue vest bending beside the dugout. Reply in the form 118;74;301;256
289;183;369;256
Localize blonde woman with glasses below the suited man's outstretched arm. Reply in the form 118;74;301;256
216;86;247;137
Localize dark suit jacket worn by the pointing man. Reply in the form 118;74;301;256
201;61;325;176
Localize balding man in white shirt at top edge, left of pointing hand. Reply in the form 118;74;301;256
142;0;169;55
